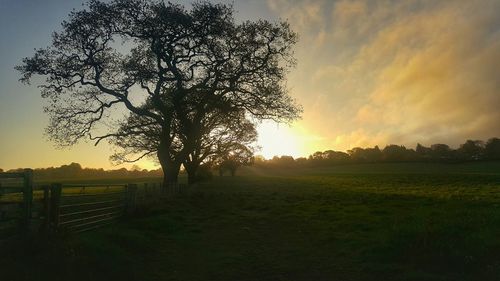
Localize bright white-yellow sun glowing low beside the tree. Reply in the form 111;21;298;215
256;122;301;159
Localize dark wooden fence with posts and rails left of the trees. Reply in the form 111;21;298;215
0;170;185;239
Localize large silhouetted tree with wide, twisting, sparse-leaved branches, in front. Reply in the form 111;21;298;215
17;0;301;188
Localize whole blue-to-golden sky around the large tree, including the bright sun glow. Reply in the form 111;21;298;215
0;0;500;169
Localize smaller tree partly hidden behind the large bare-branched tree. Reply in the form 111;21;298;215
113;101;257;184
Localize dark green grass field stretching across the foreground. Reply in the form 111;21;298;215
0;163;500;281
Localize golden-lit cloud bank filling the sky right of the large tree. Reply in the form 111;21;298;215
269;0;500;152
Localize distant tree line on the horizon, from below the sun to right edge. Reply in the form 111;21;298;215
254;138;500;167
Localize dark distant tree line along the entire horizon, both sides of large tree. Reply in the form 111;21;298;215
0;138;500;180
